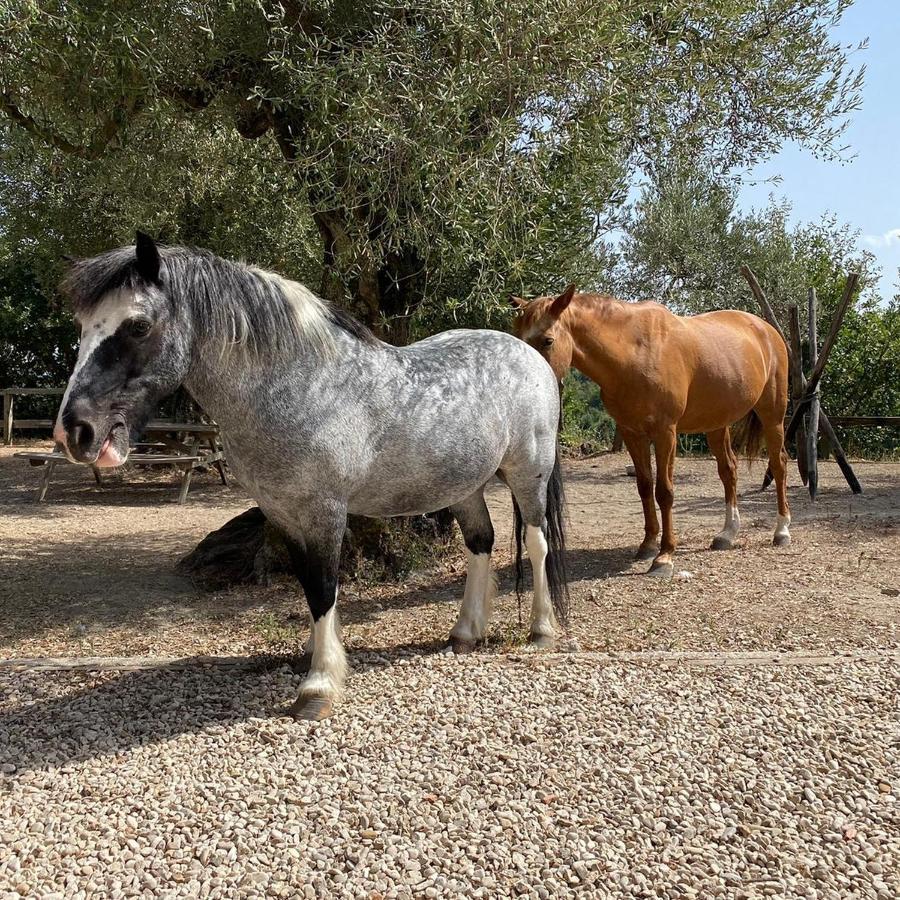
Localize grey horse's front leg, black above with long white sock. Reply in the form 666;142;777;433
286;508;347;720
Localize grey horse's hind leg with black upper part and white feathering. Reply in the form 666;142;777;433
450;488;497;653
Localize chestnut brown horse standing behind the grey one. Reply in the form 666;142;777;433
512;285;791;575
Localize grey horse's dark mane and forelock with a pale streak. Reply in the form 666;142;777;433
60;246;377;353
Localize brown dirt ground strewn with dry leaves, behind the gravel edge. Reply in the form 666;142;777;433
0;448;900;657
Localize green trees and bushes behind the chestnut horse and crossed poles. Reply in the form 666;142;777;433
612;162;900;453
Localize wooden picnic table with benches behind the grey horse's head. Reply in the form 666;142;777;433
16;419;228;504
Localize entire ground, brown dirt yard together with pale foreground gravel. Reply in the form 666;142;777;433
0;448;900;900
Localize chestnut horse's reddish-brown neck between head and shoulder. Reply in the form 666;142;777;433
568;296;632;390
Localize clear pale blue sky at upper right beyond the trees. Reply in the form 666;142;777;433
739;0;900;296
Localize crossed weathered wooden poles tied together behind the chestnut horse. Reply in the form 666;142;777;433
741;265;864;494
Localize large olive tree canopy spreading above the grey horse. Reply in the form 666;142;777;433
0;0;860;341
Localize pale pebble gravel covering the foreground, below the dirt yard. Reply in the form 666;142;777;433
0;653;900;900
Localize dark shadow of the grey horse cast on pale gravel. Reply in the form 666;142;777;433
0;642;512;775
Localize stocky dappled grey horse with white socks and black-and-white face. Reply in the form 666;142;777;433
54;233;567;719
